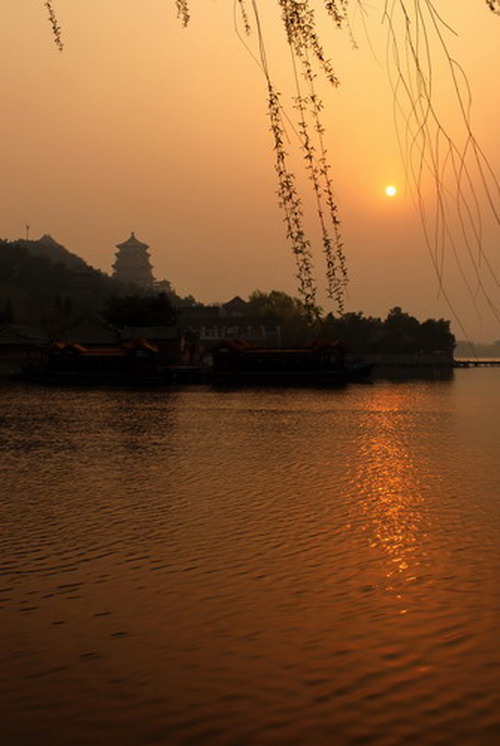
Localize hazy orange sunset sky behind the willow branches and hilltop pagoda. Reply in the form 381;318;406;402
0;0;500;341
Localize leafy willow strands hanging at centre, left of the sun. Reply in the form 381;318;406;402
244;0;347;318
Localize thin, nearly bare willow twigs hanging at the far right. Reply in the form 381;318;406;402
384;0;500;336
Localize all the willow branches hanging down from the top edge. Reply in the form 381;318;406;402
44;0;500;330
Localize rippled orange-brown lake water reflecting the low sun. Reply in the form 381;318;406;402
0;369;500;746
